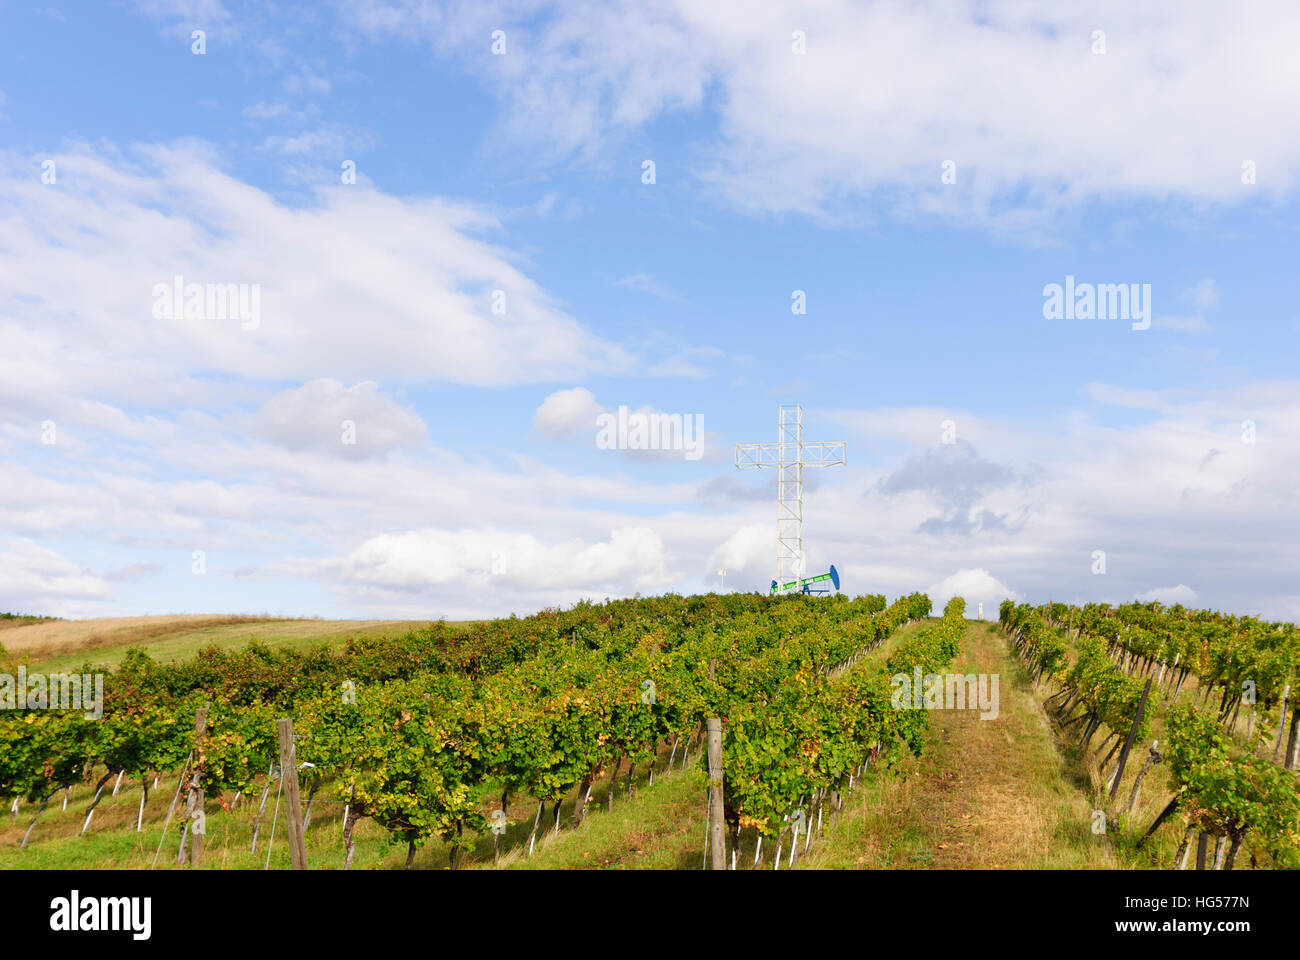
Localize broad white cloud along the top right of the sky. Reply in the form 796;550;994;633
346;0;1300;221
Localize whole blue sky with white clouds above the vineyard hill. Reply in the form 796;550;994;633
0;0;1300;619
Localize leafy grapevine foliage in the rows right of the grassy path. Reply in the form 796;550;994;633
1000;601;1300;869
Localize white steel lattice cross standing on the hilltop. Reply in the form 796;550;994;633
736;403;848;584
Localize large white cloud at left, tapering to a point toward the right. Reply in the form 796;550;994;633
0;144;629;416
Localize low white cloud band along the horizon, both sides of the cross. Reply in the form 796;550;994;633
0;382;1300;618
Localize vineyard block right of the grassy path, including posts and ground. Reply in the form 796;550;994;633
1000;601;1300;869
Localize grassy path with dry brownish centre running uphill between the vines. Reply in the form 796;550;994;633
803;622;1128;869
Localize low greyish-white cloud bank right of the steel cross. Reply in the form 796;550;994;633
803;381;1300;619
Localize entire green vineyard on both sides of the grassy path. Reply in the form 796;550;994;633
0;593;1300;869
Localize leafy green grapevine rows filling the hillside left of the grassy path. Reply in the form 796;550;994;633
0;594;956;864
